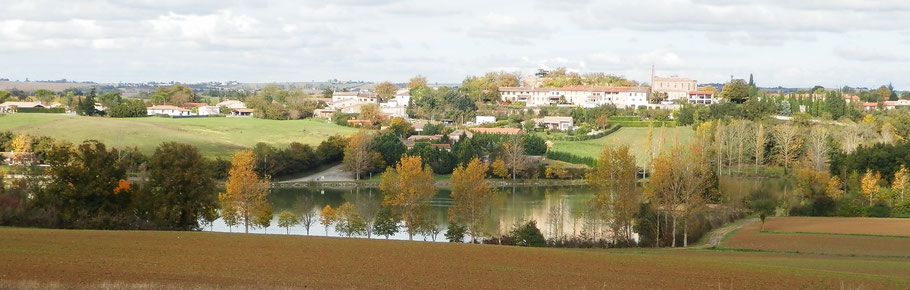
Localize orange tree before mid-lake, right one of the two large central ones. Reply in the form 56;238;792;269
449;158;493;242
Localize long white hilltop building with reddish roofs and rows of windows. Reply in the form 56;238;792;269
499;86;648;108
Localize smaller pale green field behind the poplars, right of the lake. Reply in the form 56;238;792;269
553;127;695;165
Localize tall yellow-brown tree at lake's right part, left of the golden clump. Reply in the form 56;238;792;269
586;146;641;244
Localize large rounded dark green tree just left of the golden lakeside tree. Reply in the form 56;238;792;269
148;142;218;230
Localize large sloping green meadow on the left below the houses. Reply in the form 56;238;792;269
0;114;355;157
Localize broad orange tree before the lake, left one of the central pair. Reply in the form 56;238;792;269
379;155;436;240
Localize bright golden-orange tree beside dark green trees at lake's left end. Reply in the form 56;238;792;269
218;150;272;233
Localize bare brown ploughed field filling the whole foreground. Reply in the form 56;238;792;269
0;228;910;289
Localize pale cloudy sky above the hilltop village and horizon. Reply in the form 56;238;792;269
0;0;910;90
